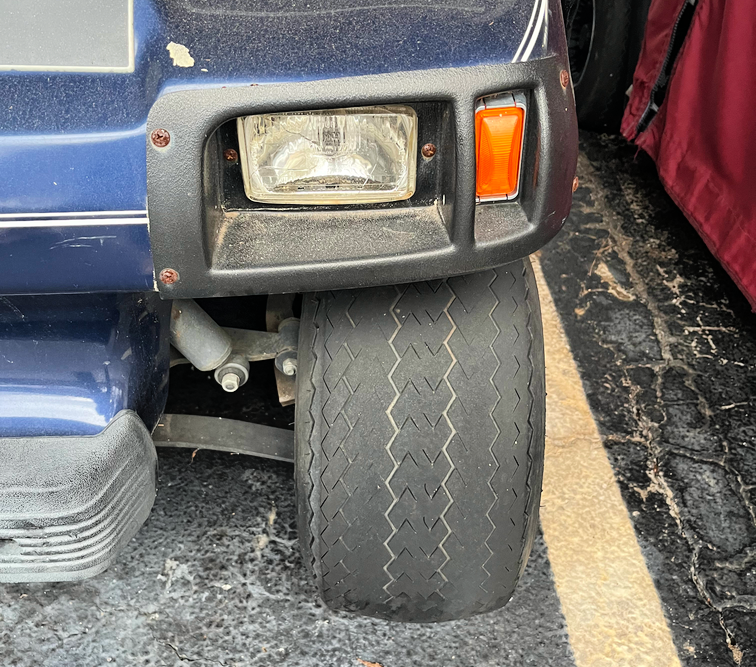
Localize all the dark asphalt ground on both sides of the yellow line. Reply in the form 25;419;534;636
0;134;756;667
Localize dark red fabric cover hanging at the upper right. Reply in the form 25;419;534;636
622;0;756;310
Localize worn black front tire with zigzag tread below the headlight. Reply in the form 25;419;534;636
295;259;545;622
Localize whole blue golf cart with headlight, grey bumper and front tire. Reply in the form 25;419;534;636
0;0;577;621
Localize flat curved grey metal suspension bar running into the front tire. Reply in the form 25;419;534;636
152;414;294;463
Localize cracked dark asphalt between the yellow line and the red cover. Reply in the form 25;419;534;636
542;135;756;666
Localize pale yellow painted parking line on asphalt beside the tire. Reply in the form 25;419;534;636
532;256;680;667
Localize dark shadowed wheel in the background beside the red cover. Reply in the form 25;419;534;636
563;0;637;132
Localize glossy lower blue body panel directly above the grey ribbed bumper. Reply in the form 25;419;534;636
0;293;170;437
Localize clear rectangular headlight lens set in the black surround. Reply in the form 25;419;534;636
237;105;417;204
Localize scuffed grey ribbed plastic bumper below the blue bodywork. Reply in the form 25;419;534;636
0;410;157;583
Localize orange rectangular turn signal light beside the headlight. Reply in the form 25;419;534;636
475;106;525;199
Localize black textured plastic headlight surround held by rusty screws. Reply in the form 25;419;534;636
147;56;577;298
